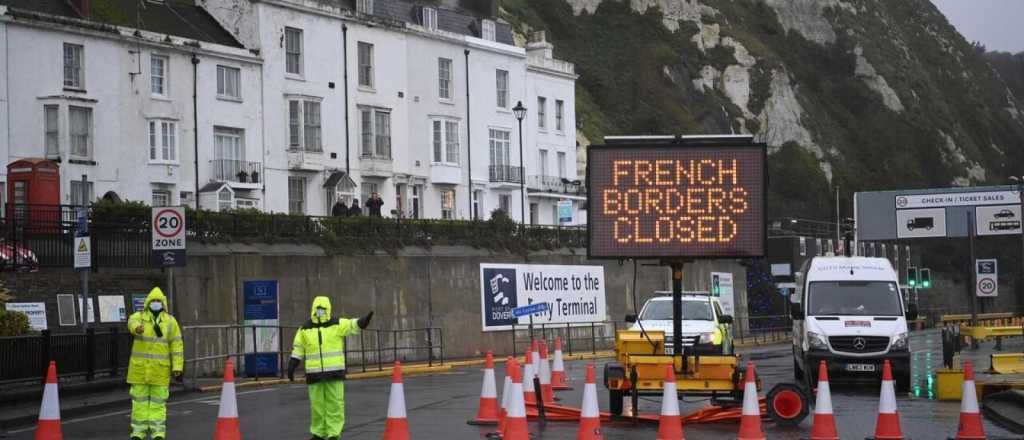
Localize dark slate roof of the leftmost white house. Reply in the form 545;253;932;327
0;0;243;48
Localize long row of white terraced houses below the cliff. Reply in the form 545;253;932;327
0;0;585;224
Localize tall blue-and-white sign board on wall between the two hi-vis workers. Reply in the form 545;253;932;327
242;280;281;377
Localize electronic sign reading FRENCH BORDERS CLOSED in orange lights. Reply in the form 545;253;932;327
588;144;766;259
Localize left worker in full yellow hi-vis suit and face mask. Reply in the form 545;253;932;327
128;288;184;440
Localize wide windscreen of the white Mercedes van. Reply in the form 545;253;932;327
807;281;902;316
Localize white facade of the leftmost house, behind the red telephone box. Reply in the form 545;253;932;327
0;6;262;208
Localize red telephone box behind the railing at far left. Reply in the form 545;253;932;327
7;159;60;226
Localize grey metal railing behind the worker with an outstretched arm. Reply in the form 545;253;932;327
182;324;444;384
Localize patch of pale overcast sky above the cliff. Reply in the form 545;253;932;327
932;0;1024;53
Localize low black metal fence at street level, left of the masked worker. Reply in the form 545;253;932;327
0;328;132;385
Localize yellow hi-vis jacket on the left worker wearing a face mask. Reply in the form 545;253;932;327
128;288;184;385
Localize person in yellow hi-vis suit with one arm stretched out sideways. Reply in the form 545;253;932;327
288;297;374;440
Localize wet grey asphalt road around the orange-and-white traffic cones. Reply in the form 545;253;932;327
7;331;1021;440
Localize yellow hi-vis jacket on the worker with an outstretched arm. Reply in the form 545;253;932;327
292;297;359;384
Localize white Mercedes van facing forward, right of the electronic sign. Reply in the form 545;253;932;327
791;257;918;391
